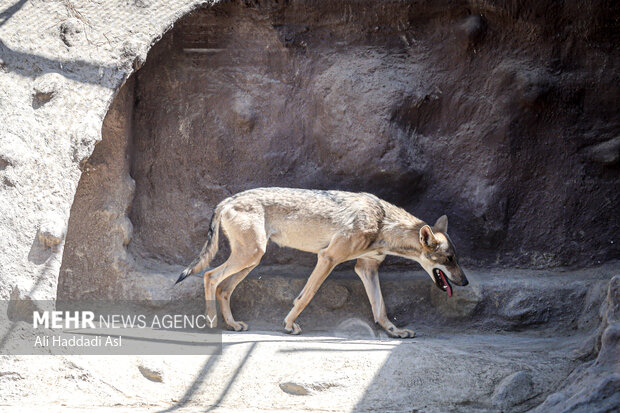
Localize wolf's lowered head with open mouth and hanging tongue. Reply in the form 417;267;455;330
418;215;469;297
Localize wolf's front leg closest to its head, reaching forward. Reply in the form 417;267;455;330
355;257;415;338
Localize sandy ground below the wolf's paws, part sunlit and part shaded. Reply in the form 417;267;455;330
0;322;584;412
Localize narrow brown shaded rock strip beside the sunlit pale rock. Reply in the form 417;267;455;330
57;78;135;300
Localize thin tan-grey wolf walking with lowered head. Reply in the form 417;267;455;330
175;188;468;338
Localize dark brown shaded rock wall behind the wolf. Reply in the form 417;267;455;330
130;1;620;268
